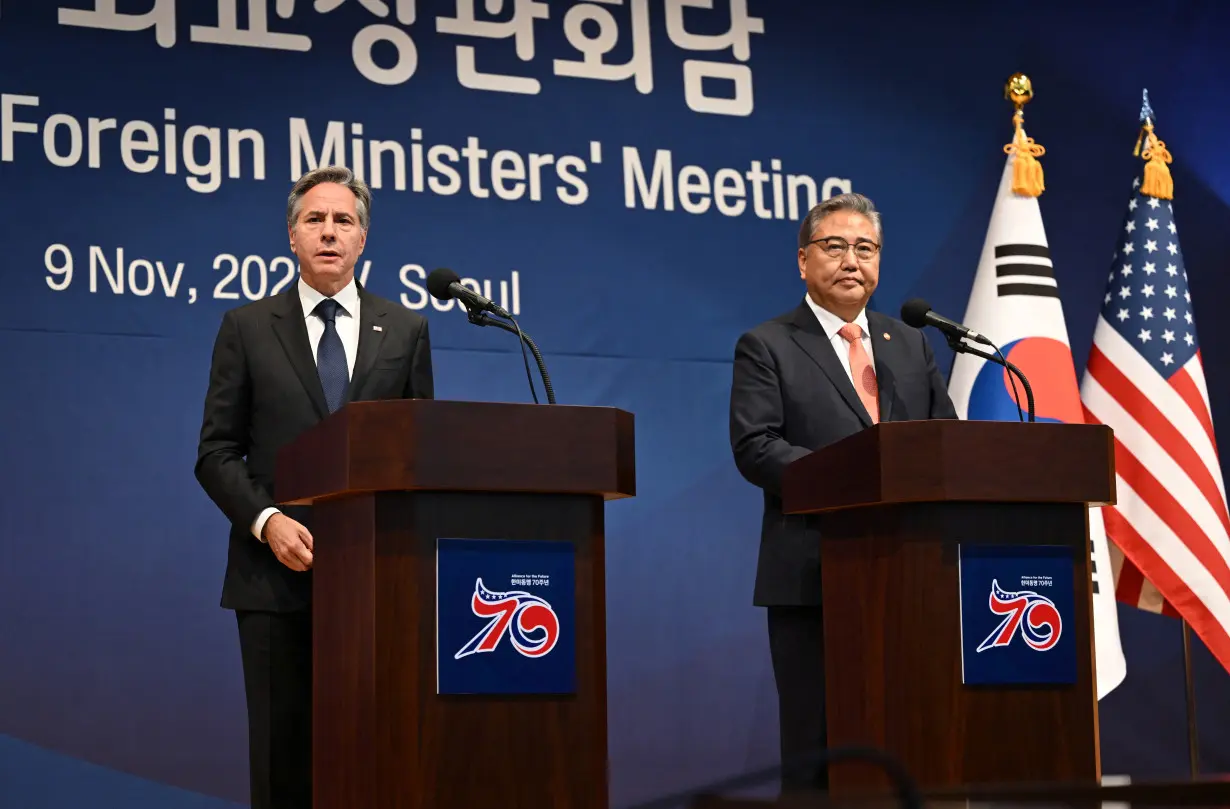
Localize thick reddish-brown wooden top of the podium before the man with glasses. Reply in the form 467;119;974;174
782;419;1116;514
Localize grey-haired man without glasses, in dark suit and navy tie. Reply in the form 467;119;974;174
196;167;434;809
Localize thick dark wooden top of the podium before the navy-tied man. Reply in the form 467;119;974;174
274;400;636;505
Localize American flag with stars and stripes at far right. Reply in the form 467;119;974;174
1081;143;1230;669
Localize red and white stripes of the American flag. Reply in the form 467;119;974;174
1081;317;1230;669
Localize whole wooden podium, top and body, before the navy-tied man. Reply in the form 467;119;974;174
276;400;636;809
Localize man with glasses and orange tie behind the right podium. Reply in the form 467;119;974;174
731;194;957;792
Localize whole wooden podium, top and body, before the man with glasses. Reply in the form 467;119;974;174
782;420;1114;797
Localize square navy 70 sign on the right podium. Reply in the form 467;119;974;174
958;541;1085;685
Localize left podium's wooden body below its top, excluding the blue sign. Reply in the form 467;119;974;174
314;492;608;809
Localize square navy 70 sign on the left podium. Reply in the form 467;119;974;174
435;539;577;695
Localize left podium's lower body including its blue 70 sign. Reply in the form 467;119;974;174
312;484;608;809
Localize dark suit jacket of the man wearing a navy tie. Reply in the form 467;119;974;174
196;284;434;611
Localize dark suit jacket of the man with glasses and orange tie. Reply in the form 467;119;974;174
731;301;957;606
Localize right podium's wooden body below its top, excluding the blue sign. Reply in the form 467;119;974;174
819;504;1098;794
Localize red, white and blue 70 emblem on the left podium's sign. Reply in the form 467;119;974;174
453;578;560;660
